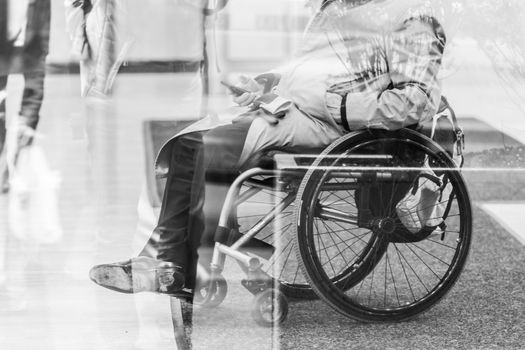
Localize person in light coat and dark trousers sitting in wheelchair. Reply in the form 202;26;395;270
90;0;445;293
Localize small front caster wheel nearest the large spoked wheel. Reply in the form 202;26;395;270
252;288;288;327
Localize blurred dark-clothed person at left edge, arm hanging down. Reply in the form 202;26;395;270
0;0;51;190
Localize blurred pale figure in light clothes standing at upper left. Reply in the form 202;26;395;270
64;0;130;227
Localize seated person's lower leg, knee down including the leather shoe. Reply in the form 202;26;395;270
90;132;206;293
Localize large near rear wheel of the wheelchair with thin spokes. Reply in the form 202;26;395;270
295;129;472;322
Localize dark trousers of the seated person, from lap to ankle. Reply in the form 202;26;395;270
140;122;251;288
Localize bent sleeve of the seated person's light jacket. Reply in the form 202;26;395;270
345;16;446;130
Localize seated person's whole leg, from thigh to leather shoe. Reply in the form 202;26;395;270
90;113;340;293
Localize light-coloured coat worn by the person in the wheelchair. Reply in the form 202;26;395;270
156;0;445;176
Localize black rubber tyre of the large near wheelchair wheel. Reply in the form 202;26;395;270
295;129;472;322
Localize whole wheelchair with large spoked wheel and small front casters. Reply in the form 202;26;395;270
192;128;472;326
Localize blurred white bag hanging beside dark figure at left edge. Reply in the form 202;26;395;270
8;145;62;243
